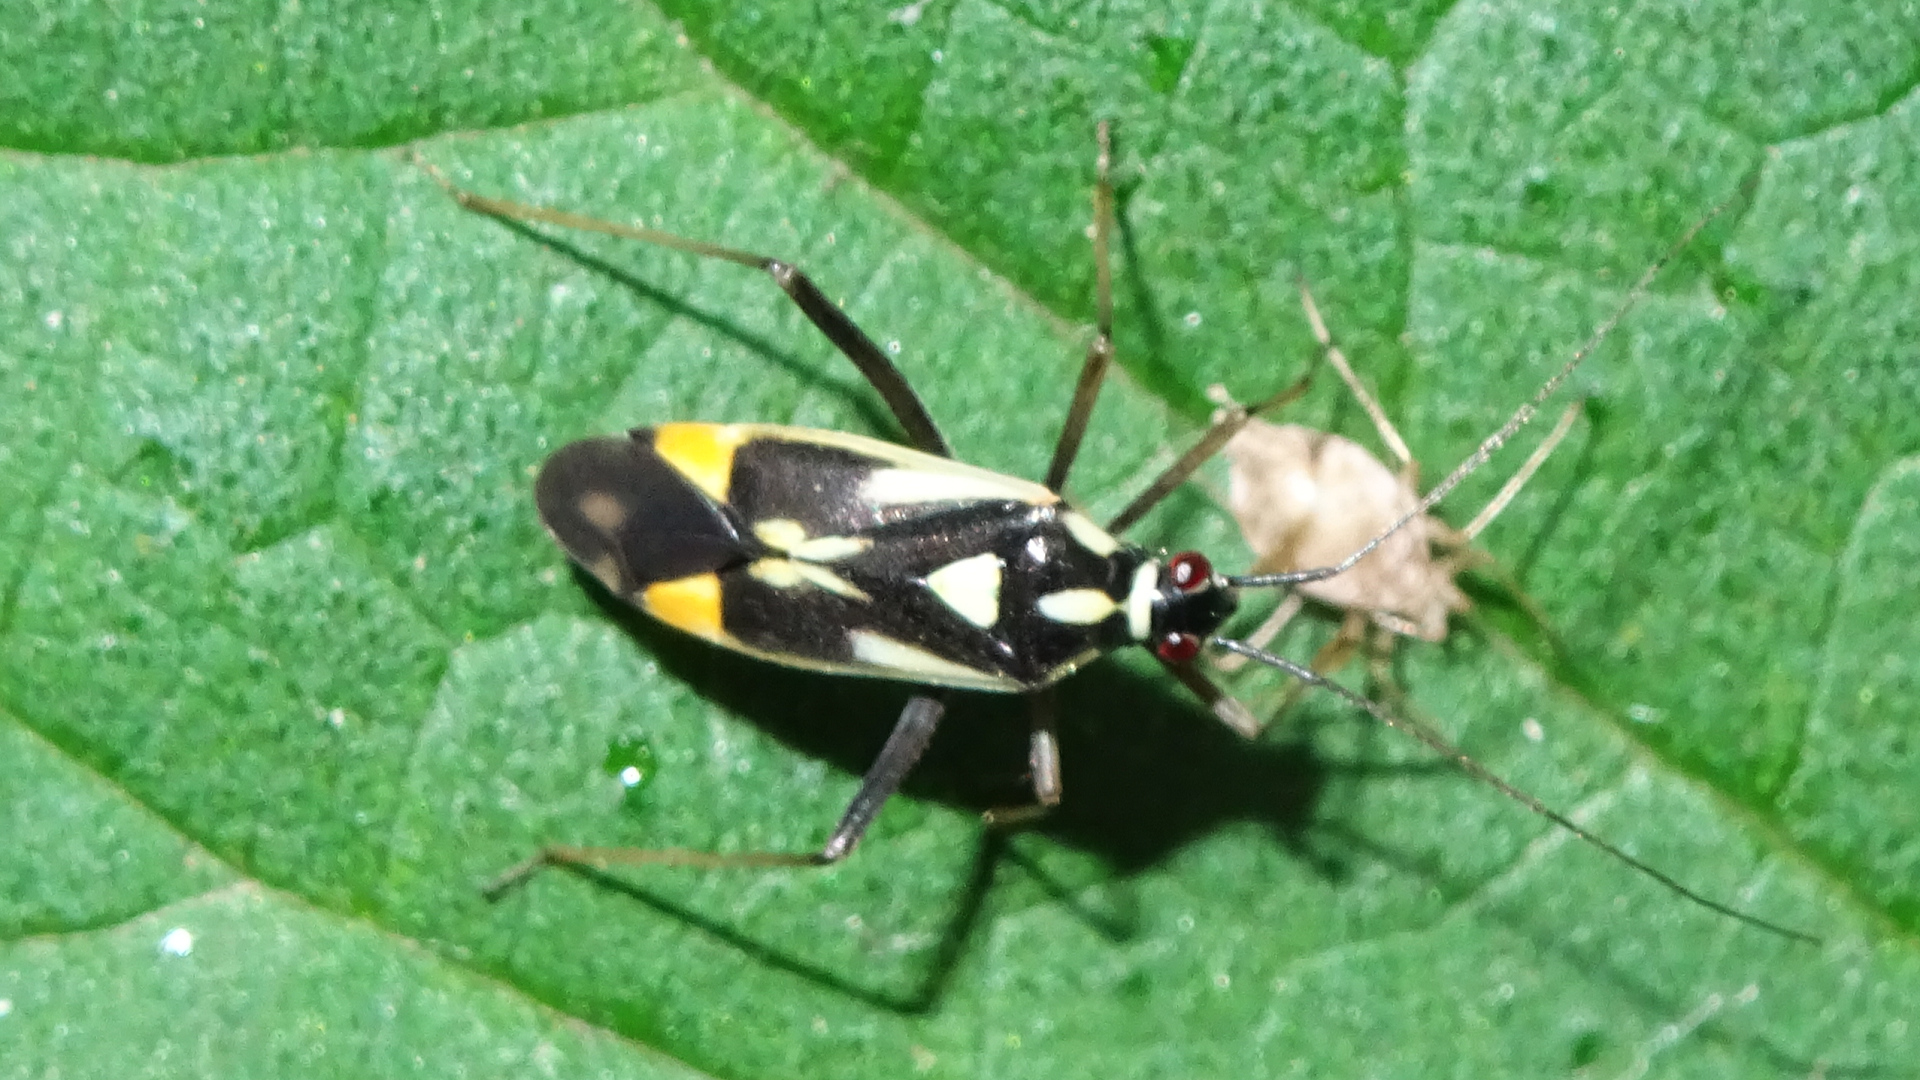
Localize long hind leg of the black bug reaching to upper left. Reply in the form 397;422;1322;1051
415;158;952;457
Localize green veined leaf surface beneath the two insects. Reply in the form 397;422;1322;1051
0;0;1920;1078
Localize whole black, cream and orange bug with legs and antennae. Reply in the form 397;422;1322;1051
422;123;1811;940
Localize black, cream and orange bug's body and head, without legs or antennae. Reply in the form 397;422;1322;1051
534;423;1233;694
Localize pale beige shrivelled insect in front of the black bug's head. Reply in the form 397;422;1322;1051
1208;272;1582;692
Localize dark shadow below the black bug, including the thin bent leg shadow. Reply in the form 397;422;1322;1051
556;571;1367;1013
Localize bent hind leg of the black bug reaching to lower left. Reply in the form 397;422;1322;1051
482;694;947;899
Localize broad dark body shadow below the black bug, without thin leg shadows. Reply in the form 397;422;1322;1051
576;573;1327;874
